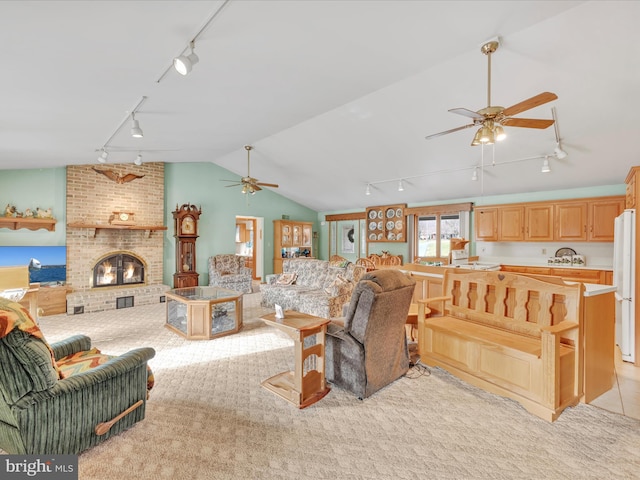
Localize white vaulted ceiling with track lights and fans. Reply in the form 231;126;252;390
0;0;640;211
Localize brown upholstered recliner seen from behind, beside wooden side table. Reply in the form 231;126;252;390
325;270;415;399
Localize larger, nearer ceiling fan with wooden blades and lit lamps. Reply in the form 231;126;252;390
425;39;558;146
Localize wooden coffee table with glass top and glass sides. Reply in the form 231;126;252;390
165;287;242;340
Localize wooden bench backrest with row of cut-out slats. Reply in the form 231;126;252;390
442;269;584;337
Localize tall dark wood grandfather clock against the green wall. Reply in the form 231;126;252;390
172;203;202;288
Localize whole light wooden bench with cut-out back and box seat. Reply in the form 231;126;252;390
418;269;584;421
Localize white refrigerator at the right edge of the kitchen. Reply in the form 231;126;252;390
613;210;636;362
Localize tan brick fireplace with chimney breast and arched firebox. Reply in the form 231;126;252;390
67;163;169;314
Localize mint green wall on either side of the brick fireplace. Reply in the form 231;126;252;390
0;163;317;285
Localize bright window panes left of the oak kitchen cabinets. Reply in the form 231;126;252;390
415;213;462;257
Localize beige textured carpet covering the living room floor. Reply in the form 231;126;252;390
23;294;640;480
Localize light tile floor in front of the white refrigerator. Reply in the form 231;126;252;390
591;347;640;420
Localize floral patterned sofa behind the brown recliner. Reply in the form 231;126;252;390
260;259;365;318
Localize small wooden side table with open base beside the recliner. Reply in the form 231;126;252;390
260;310;331;408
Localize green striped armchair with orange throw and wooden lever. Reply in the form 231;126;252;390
0;298;155;455
